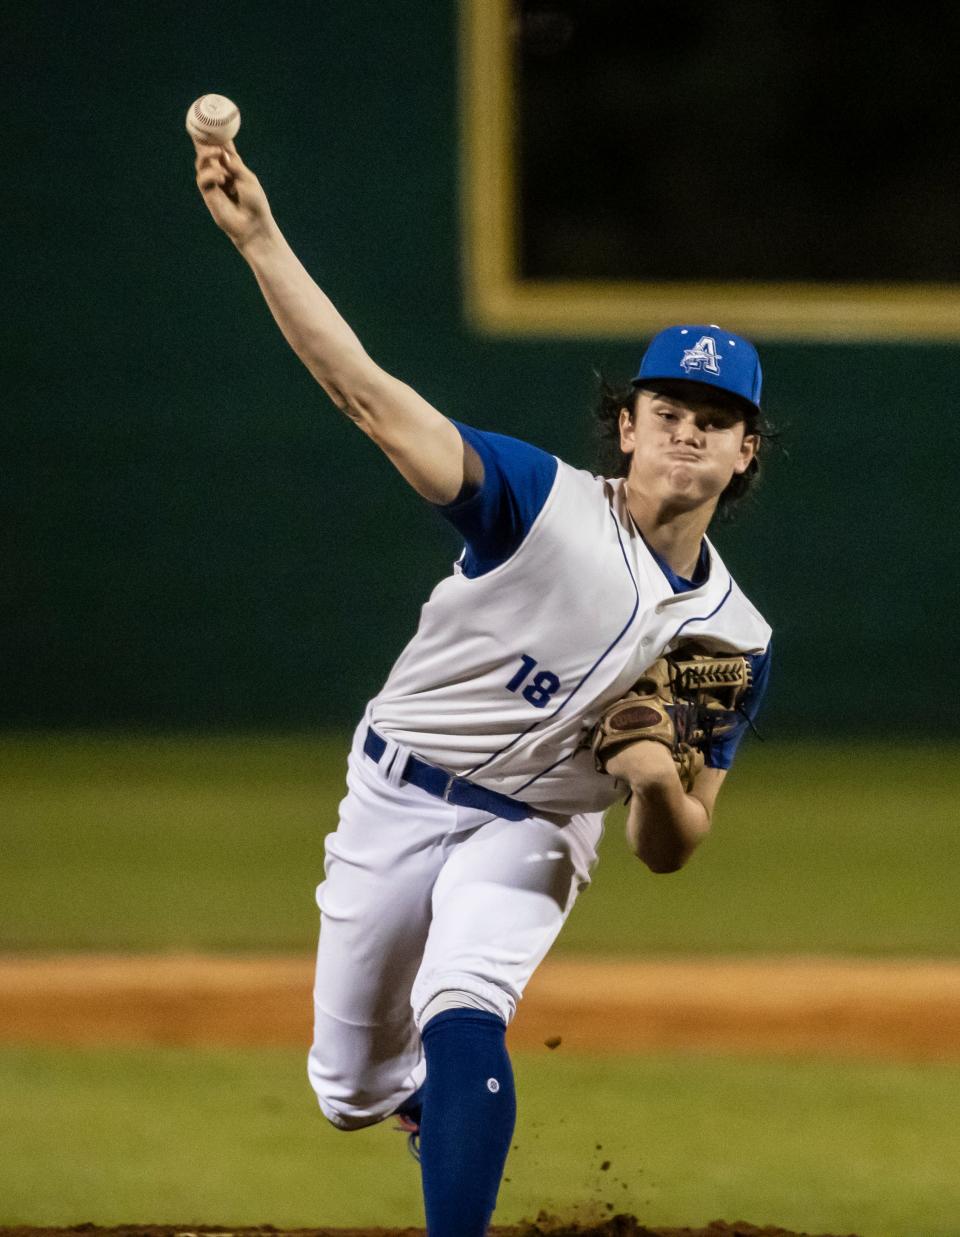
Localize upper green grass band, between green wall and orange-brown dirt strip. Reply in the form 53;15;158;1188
0;737;960;955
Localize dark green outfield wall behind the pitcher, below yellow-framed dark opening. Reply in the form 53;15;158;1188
0;0;960;736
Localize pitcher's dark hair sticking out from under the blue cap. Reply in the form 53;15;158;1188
594;374;779;520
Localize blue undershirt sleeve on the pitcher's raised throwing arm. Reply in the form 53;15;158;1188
437;421;558;576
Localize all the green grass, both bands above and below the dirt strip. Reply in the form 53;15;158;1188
0;736;960;1237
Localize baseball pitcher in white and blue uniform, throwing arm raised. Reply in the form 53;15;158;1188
195;142;771;1237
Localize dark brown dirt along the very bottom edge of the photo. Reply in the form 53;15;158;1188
0;1216;857;1237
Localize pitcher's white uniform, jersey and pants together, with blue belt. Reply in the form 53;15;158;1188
308;426;771;1128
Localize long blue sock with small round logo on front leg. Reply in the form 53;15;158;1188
421;1009;517;1237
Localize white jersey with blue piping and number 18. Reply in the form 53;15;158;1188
367;426;771;814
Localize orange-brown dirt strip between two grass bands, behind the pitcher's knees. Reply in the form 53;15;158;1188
7;954;960;1061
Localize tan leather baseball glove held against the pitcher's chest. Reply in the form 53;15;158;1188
590;646;752;793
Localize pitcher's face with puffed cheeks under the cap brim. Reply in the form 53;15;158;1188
620;388;760;511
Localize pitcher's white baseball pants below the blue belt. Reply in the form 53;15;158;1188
308;719;602;1129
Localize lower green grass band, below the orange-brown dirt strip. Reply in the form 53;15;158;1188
0;1048;960;1237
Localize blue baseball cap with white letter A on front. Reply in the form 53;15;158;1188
633;323;763;412
